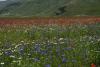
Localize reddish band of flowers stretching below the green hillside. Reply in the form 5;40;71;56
0;17;100;26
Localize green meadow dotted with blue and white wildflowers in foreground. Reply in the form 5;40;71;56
0;23;100;67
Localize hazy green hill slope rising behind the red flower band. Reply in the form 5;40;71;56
0;0;100;17
